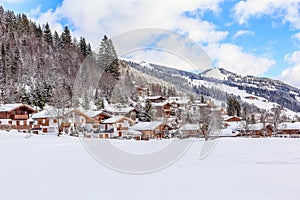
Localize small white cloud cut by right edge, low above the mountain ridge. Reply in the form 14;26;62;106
278;51;300;88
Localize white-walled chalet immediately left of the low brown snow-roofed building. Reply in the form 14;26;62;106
100;115;135;138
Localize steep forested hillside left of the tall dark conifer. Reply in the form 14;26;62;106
0;7;91;107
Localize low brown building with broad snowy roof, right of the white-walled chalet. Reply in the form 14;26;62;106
131;121;168;140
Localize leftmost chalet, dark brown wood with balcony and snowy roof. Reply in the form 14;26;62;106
0;103;35;130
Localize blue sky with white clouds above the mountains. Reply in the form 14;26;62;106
0;0;300;87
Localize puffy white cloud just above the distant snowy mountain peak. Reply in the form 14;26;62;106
207;43;276;76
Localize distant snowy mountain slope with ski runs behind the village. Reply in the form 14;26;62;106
124;59;300;115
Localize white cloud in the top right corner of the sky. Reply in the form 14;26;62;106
233;0;300;29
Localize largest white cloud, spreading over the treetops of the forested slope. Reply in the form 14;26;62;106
31;0;228;47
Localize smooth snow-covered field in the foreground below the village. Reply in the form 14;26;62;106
0;131;300;200
